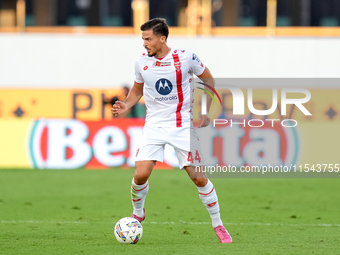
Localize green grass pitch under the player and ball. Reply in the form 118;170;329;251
0;169;340;254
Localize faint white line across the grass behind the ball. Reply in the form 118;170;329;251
0;220;340;227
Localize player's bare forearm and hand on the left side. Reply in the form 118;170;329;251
111;82;144;117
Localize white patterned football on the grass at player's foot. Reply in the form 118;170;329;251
115;217;143;244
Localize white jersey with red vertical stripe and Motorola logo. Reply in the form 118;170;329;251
135;49;205;127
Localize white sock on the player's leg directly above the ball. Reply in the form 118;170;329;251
131;179;149;218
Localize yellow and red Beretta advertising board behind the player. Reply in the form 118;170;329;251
0;118;340;169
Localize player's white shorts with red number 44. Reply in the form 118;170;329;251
136;127;204;169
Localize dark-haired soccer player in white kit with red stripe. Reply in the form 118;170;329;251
112;18;232;243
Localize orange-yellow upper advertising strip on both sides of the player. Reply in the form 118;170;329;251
0;89;340;123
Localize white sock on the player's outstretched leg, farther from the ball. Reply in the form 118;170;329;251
197;180;223;228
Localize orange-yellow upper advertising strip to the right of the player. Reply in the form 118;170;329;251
194;89;340;123
